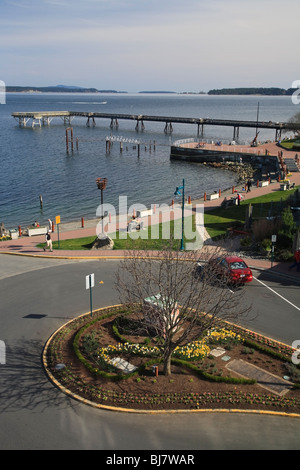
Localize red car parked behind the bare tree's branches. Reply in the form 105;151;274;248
210;256;253;284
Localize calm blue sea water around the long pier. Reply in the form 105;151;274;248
0;93;298;228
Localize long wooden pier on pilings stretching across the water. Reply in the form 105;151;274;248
12;111;300;140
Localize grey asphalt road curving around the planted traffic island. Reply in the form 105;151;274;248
0;255;300;453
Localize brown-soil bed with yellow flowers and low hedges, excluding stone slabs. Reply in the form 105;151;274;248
44;306;300;413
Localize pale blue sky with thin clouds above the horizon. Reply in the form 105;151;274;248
0;0;300;93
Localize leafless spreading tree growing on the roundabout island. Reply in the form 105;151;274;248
116;247;249;375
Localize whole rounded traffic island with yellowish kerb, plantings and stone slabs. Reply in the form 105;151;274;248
43;305;300;418
